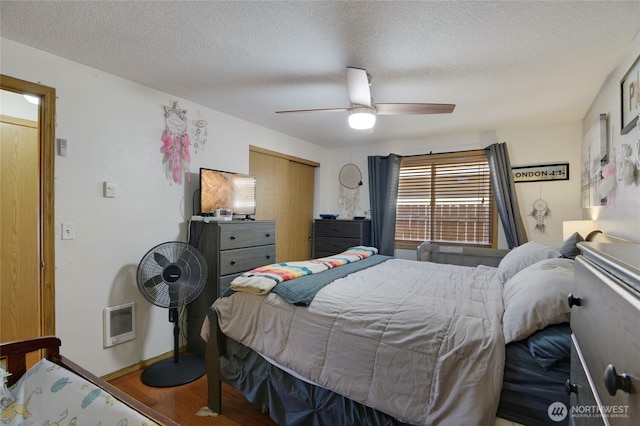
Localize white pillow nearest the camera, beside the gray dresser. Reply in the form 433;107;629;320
502;259;574;343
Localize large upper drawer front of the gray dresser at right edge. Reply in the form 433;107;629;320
571;256;640;425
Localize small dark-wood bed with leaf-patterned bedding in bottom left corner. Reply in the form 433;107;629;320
0;336;178;426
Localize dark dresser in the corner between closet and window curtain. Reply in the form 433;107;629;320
311;219;371;259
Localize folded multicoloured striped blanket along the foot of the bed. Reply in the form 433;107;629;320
231;246;378;294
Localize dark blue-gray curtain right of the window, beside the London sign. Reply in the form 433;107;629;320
485;142;528;248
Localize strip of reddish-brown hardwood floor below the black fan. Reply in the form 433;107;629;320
109;370;276;426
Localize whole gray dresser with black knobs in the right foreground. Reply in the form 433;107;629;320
567;242;640;425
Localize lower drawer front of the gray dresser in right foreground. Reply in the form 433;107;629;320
567;335;604;426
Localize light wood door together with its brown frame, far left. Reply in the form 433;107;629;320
0;75;56;342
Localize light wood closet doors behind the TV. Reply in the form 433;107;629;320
249;147;319;262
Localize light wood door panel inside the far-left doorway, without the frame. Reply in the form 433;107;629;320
0;116;41;342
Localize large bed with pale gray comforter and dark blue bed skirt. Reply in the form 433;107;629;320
202;233;624;425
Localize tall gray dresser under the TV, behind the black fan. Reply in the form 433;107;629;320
187;220;276;356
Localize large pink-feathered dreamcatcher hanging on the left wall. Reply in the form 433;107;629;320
161;101;191;183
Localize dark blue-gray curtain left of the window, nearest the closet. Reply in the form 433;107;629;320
368;154;402;256
